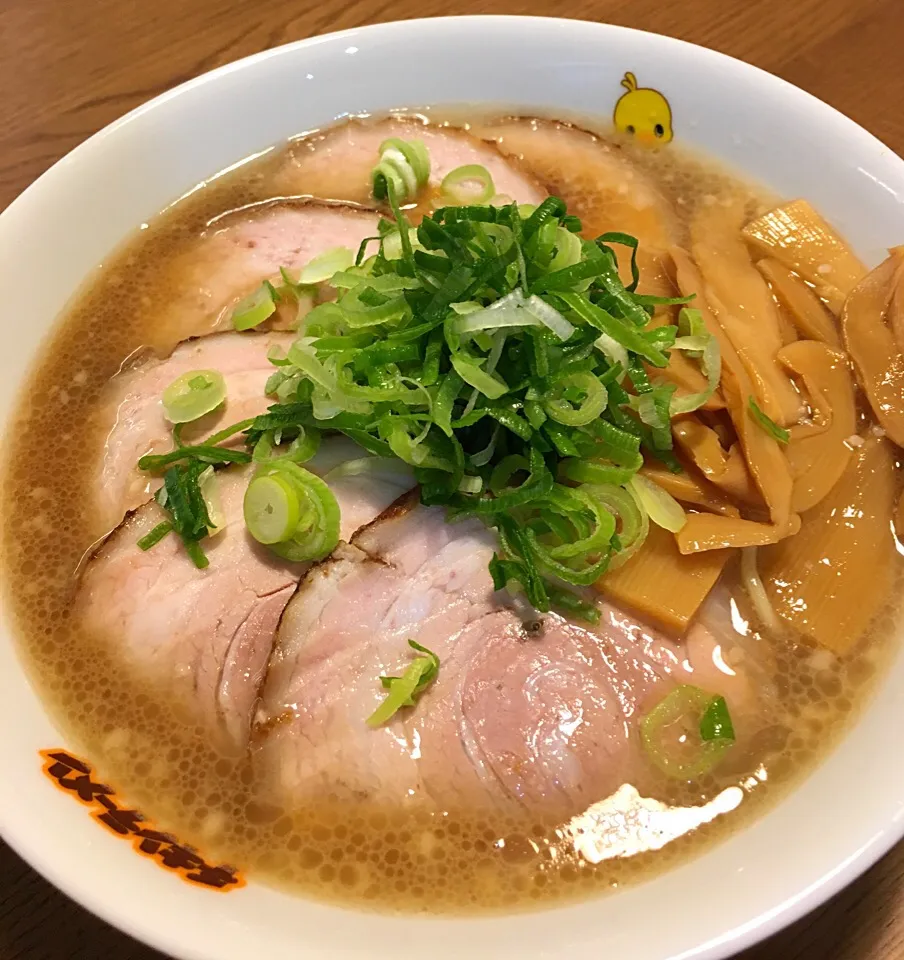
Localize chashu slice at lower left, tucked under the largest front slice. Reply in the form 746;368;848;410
75;438;414;747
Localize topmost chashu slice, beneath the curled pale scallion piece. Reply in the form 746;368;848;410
279;120;546;210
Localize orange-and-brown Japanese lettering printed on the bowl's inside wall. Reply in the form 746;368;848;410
40;750;245;892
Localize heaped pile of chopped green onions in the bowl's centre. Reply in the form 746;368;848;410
140;188;719;621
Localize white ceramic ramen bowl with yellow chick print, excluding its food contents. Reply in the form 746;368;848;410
0;17;904;960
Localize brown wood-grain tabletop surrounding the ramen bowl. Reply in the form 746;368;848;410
0;0;904;960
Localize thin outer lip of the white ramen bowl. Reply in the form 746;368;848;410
0;14;904;960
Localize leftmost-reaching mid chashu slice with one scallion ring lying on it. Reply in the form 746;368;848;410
92;332;294;537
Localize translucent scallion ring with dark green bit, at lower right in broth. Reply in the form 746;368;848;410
640;684;734;780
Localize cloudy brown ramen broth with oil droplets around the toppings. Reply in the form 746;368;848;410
0;116;898;913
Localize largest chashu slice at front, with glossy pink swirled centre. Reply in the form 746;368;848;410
254;497;756;815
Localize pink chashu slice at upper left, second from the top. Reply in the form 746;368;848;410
150;202;379;350
